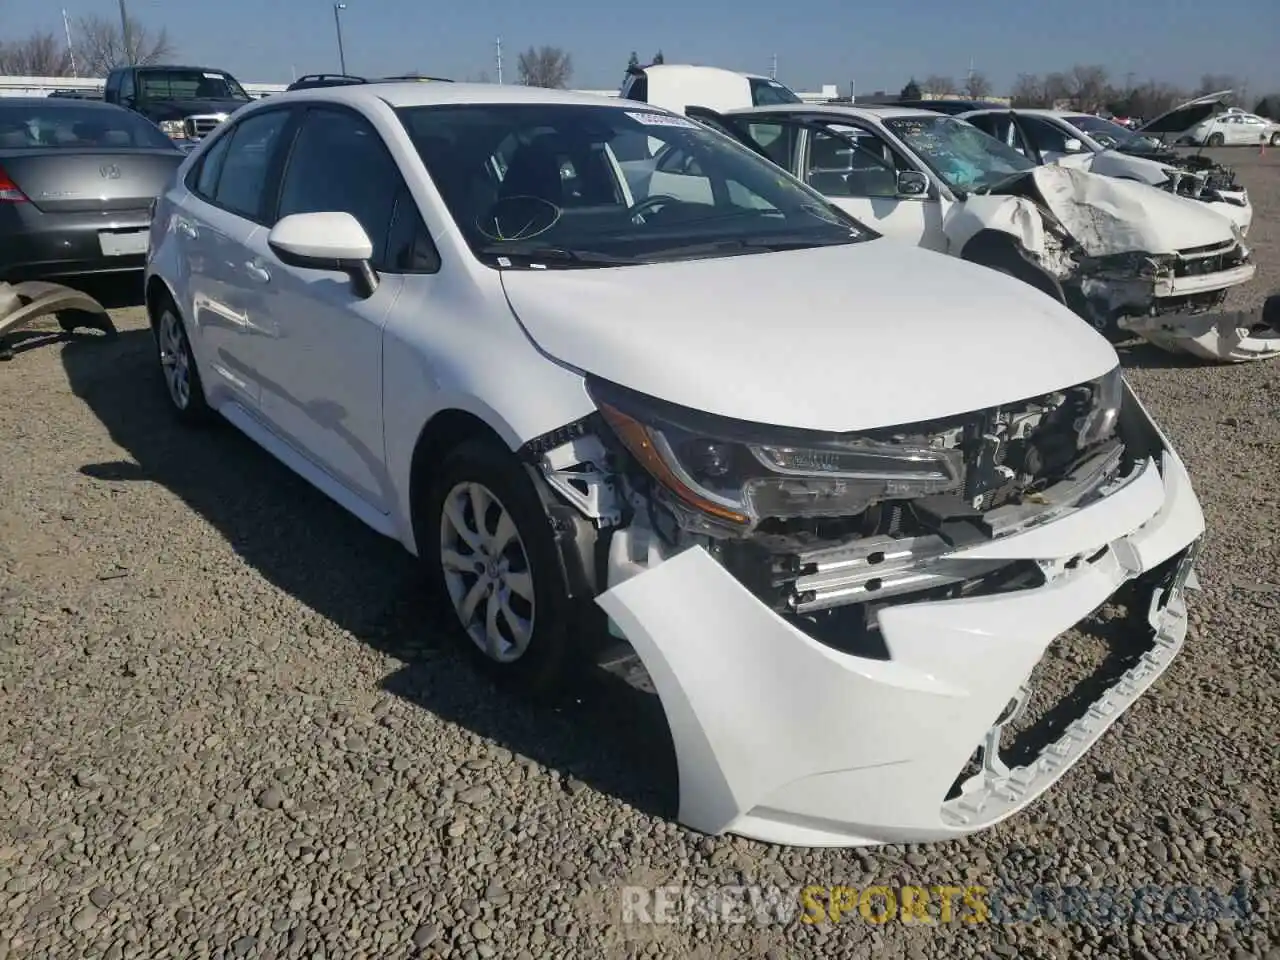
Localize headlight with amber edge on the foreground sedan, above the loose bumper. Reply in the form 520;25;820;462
589;381;964;527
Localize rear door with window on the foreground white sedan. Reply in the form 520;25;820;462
175;108;293;413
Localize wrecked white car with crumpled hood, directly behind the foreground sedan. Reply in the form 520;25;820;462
691;105;1280;361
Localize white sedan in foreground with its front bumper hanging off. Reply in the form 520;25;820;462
147;83;1204;845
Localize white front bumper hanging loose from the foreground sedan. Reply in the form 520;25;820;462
598;407;1204;846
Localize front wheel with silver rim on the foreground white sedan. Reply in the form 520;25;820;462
415;440;585;699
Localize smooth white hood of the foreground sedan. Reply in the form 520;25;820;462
502;239;1117;431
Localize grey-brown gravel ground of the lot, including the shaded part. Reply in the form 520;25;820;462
0;151;1280;960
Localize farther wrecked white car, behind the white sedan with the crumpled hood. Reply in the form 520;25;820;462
959;101;1253;236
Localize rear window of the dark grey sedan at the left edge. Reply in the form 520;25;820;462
0;100;175;150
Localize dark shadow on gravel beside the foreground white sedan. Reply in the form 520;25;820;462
63;329;677;817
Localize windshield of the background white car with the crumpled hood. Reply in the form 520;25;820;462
884;116;1036;193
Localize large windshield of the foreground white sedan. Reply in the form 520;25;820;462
397;104;878;268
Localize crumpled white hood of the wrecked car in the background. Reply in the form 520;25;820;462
1029;164;1235;256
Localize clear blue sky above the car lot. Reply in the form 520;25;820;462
10;0;1280;99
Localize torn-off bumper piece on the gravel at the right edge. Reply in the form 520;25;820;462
1120;293;1280;364
